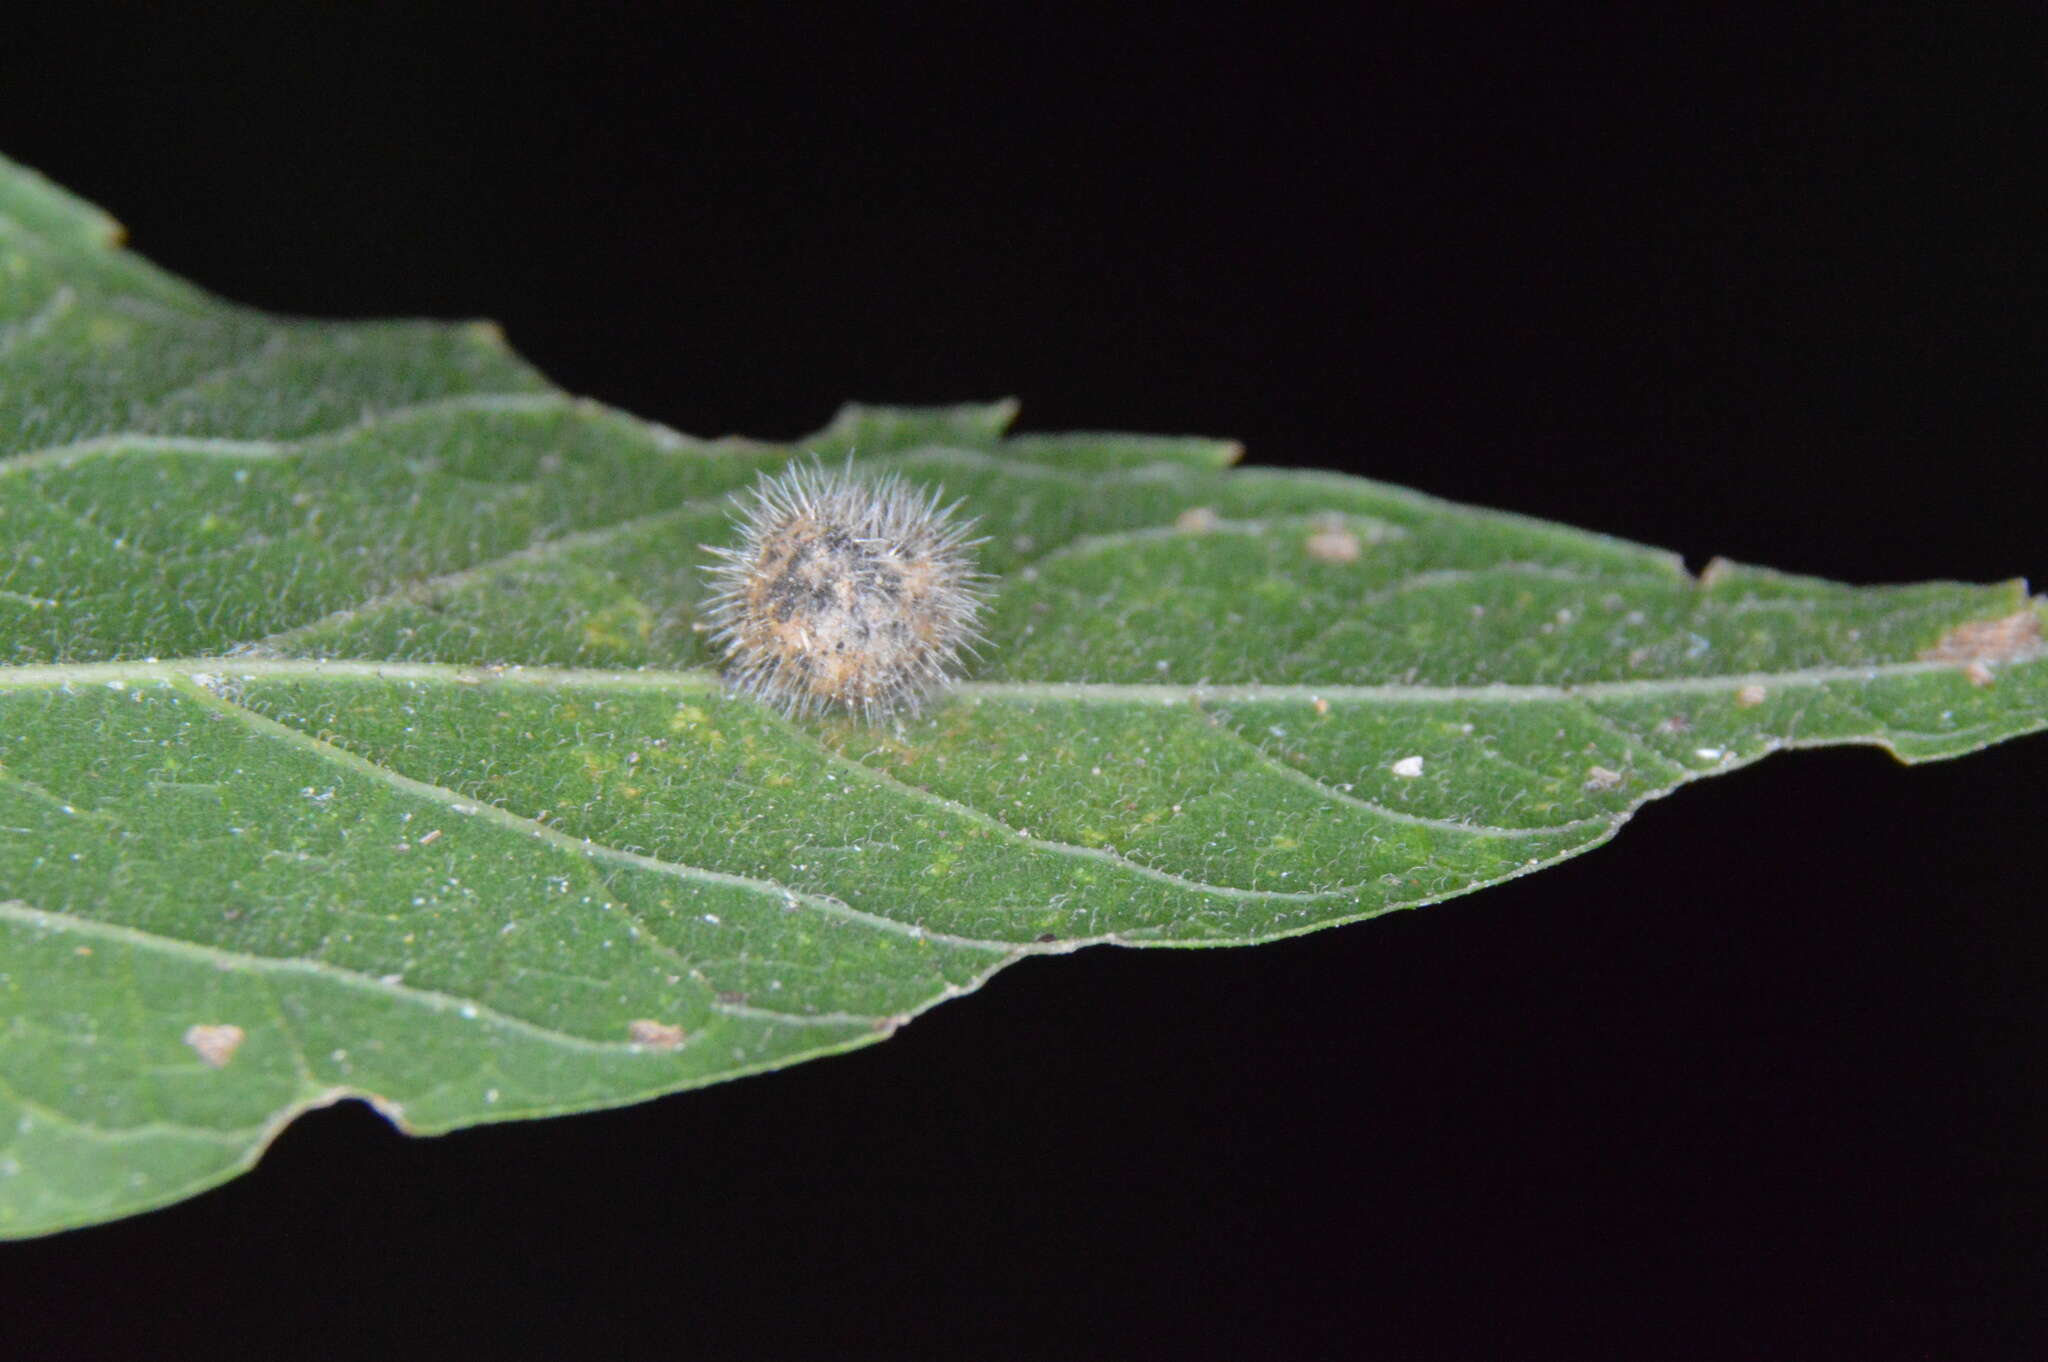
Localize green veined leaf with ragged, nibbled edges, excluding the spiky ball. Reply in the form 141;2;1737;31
0;146;2048;1235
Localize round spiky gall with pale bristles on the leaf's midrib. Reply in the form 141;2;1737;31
705;461;985;721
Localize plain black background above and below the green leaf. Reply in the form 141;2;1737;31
0;4;2048;1358
